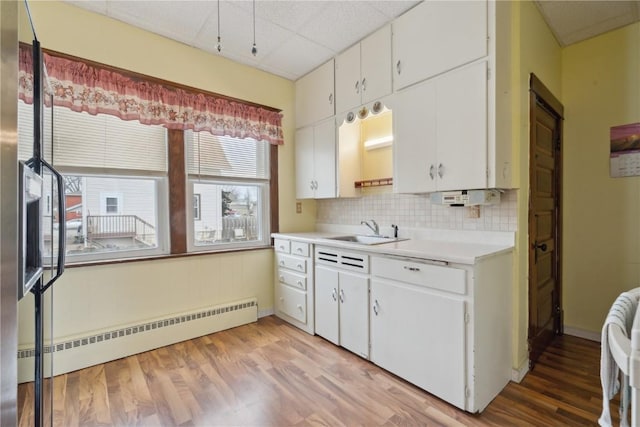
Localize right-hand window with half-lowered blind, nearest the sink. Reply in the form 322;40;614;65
185;131;269;251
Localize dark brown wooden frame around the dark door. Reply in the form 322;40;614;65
527;73;564;366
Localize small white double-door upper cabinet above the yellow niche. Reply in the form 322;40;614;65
336;25;392;112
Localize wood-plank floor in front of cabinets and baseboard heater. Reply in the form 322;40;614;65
18;316;618;426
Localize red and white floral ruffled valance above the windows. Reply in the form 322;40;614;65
18;45;284;144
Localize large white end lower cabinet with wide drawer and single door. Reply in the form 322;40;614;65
370;253;511;412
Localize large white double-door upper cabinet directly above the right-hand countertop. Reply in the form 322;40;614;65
393;61;487;193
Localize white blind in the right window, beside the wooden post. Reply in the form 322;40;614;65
185;131;269;179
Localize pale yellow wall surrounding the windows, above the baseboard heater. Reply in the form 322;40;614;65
17;1;315;346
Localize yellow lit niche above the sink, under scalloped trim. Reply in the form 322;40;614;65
337;101;393;197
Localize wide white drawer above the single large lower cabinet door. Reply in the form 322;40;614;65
371;257;467;295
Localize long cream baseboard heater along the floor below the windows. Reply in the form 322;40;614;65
18;298;258;383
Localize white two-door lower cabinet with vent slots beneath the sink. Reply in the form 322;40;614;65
315;247;369;359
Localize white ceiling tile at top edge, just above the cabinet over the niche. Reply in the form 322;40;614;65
300;1;388;52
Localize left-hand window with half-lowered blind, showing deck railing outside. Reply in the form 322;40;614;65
19;101;169;263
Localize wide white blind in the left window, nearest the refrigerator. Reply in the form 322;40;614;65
18;102;167;172
